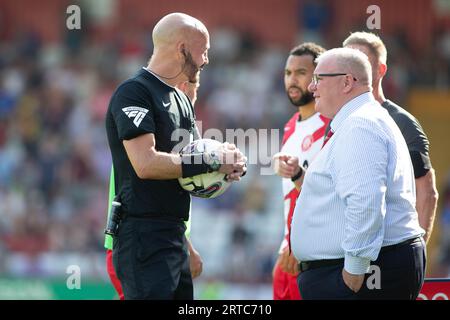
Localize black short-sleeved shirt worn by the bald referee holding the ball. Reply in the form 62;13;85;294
106;69;195;220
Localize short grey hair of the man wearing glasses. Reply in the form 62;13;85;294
316;48;372;86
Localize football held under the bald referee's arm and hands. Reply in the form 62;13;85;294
178;139;231;198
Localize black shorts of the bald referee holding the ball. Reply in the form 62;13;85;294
113;216;193;300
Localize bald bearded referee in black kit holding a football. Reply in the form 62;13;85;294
106;13;246;300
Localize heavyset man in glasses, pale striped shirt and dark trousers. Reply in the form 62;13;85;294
291;48;426;299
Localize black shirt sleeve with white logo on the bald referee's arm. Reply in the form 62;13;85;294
111;81;155;140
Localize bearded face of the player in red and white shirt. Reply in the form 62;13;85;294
284;54;314;107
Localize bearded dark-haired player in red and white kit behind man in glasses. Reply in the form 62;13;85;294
272;42;329;300
